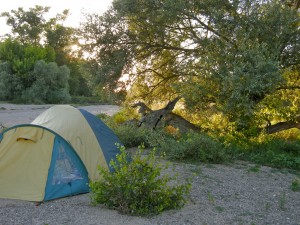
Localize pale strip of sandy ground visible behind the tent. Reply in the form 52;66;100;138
0;104;119;127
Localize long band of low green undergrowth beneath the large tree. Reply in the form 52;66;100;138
104;105;300;171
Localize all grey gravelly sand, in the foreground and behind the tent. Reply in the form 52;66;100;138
0;104;300;225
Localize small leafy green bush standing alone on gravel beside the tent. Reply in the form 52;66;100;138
90;147;190;215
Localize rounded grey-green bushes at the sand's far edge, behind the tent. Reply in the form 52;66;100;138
0;61;71;104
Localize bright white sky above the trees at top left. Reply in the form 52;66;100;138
0;0;113;36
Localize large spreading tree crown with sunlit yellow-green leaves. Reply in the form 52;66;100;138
83;0;300;133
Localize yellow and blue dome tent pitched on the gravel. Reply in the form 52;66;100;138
0;105;121;202
